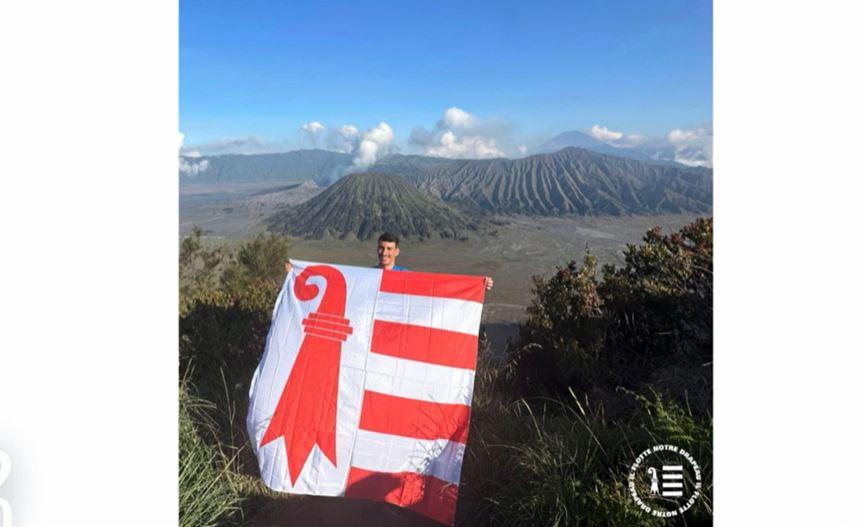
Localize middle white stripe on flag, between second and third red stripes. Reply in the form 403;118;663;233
365;353;474;406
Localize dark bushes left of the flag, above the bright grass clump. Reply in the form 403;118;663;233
179;233;287;504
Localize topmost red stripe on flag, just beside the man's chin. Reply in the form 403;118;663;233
381;269;485;303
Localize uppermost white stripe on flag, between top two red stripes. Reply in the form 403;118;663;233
374;292;482;335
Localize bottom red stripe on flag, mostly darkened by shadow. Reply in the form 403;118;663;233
345;467;458;525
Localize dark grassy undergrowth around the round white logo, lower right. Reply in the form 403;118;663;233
457;374;712;526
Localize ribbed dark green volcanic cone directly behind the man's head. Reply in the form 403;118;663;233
267;174;477;240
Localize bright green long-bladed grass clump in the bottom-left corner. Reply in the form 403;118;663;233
179;385;241;527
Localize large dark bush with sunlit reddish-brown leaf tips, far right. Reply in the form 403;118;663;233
518;219;713;411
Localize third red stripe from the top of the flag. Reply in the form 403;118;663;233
360;390;470;443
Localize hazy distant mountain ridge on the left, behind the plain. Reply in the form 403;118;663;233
180;149;352;185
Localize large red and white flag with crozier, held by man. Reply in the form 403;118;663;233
247;261;485;525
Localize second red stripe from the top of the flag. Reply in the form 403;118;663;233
371;320;477;370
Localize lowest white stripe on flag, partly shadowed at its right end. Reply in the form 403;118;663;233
351;430;464;485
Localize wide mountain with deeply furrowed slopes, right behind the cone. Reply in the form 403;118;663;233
373;147;713;216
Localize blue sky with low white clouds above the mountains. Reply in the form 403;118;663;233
180;0;713;163
